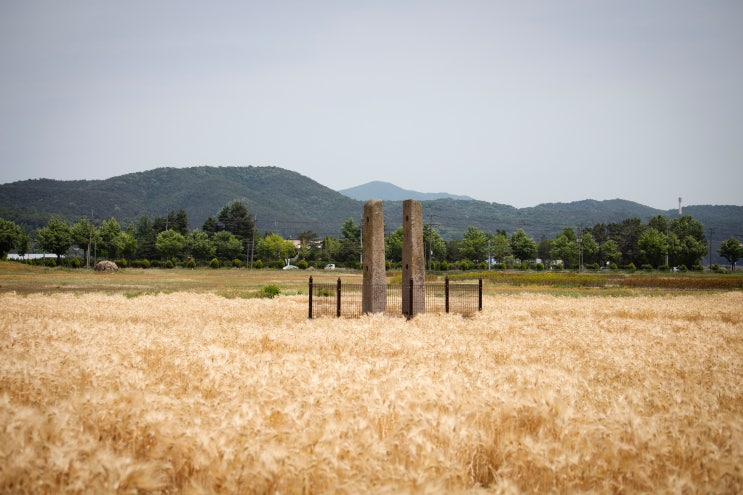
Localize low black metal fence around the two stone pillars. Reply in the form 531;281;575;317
309;277;482;318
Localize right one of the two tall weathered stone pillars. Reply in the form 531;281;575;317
402;199;426;317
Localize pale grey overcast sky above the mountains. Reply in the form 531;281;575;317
0;0;743;209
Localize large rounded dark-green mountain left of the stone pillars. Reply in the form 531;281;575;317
0;167;361;236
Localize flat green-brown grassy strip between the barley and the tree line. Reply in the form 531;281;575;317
0;261;743;298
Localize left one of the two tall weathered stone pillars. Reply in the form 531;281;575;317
361;199;387;313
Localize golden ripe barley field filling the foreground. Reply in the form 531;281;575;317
0;291;743;494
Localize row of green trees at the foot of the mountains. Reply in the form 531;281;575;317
0;201;743;270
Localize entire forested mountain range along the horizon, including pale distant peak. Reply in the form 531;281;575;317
0;166;743;264
